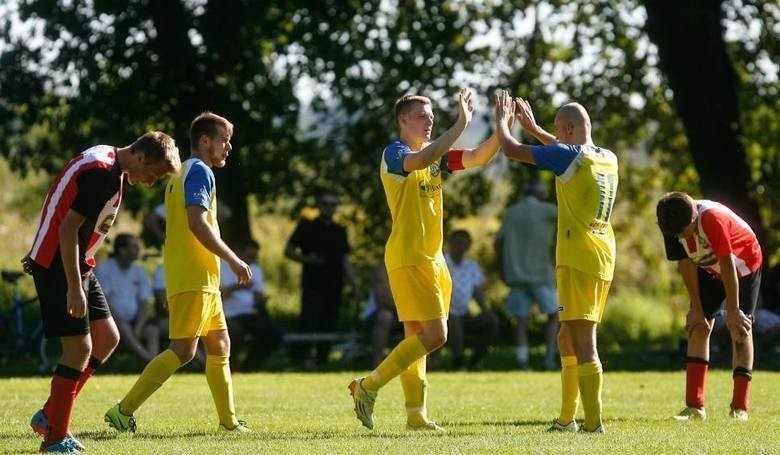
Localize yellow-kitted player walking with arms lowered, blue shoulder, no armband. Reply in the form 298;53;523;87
105;112;252;432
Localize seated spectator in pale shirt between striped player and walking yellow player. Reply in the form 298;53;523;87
95;234;160;362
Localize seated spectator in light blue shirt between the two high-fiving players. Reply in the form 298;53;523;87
444;230;498;370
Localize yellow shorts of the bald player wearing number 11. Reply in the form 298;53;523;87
555;266;612;322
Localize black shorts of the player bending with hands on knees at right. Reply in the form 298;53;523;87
698;268;761;319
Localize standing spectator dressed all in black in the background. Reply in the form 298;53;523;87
284;193;357;365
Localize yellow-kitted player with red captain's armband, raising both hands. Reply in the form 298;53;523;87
349;89;506;431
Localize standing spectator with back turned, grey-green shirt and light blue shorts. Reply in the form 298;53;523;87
494;181;558;370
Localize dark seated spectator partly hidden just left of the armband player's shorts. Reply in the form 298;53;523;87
361;261;403;366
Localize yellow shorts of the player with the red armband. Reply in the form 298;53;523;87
387;262;452;322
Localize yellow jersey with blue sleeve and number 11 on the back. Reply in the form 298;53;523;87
533;144;618;281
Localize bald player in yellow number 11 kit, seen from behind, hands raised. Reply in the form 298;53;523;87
496;90;618;433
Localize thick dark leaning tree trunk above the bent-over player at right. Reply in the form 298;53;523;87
644;0;767;249
